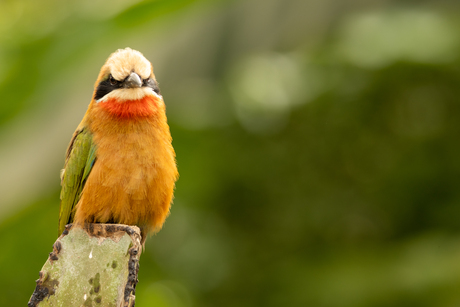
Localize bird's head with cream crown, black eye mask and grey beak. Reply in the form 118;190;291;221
93;48;163;114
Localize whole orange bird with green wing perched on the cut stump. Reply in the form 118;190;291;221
59;48;178;242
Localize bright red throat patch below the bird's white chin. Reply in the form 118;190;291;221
98;95;159;118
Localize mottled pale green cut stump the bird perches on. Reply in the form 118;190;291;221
28;224;141;307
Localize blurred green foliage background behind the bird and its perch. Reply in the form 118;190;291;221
0;0;460;307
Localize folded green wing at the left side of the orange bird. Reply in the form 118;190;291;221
58;128;96;236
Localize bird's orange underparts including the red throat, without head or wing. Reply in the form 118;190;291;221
75;100;177;236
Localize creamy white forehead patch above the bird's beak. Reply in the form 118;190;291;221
107;48;152;80
